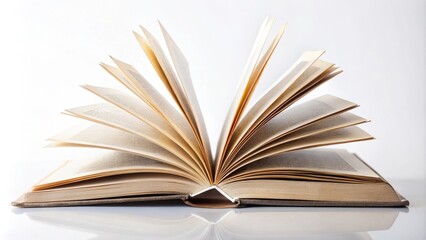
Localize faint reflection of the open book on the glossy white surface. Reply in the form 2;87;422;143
22;203;407;239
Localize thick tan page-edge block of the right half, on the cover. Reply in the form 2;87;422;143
220;179;400;202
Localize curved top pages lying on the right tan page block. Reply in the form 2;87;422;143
224;148;381;182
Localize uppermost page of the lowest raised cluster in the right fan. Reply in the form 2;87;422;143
233;95;357;164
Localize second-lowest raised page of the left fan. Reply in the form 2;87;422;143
65;103;202;171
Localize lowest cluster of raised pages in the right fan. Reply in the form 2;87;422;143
218;95;371;181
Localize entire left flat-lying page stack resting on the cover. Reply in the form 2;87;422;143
24;151;208;202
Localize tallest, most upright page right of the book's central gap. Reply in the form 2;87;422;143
215;15;273;174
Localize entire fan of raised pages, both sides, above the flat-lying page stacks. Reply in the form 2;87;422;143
47;18;372;187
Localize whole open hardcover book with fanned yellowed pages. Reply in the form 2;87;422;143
13;18;408;207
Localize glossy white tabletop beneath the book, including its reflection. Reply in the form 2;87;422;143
0;170;426;240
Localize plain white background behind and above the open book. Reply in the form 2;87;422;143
0;0;426;238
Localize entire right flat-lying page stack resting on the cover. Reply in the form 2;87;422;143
219;149;400;203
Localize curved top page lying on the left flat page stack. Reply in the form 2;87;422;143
33;150;198;190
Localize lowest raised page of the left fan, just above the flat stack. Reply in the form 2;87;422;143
49;124;206;181
